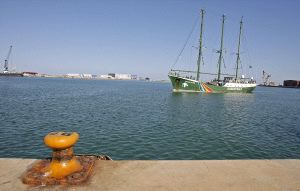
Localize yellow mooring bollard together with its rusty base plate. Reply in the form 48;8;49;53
22;132;111;186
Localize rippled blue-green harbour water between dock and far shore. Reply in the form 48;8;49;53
0;78;300;159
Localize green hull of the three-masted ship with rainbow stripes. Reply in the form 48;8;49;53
168;75;256;93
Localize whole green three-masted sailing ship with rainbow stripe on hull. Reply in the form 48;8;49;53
168;9;256;93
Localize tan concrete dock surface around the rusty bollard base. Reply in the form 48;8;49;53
0;159;300;191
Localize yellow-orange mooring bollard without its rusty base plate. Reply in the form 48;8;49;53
43;132;82;179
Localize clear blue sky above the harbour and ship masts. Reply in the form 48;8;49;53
0;0;300;83
